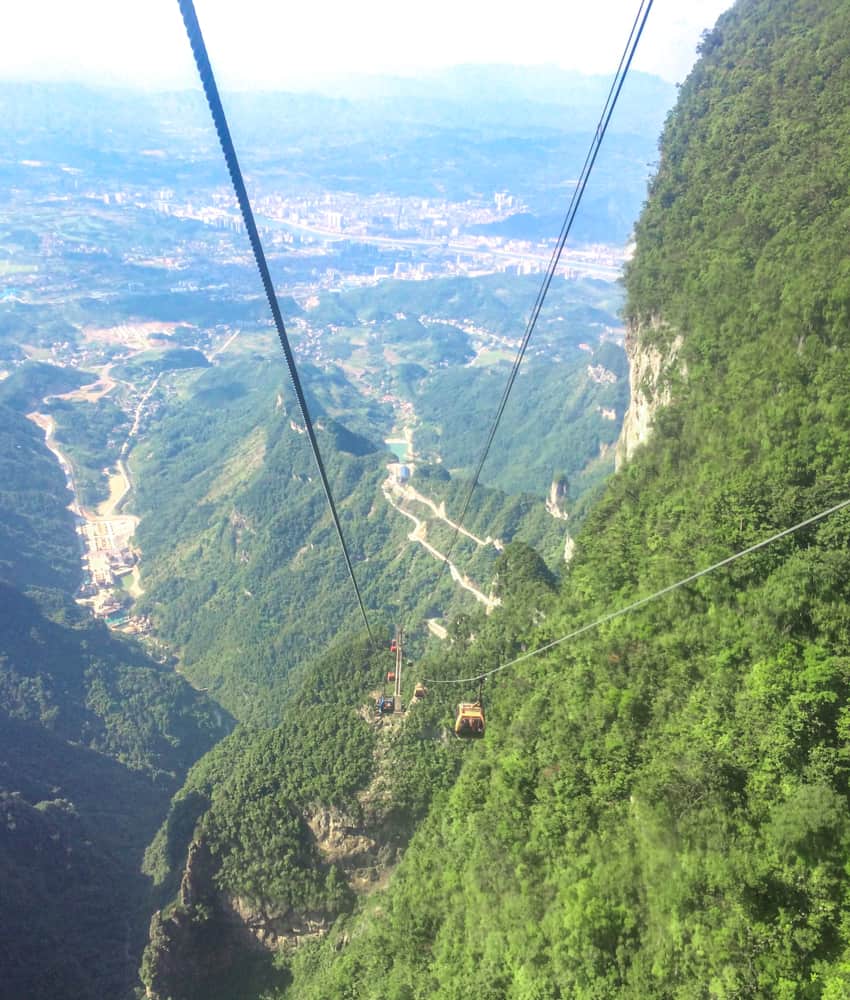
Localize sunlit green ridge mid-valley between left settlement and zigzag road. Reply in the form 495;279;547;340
133;357;565;725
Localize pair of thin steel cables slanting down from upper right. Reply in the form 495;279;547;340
440;0;653;576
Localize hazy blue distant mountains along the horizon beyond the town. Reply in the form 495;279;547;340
0;67;675;243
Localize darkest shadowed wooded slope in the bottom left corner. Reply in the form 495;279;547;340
0;712;168;1000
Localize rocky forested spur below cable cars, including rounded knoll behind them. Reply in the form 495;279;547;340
142;542;554;1000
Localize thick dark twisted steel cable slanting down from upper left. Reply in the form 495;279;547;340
177;0;375;645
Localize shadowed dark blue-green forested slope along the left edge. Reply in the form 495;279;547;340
0;380;230;1000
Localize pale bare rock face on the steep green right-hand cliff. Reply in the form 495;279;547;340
616;317;686;469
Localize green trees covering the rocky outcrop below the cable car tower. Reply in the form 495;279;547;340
142;624;468;997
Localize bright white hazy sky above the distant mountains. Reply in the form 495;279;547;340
0;0;732;88
